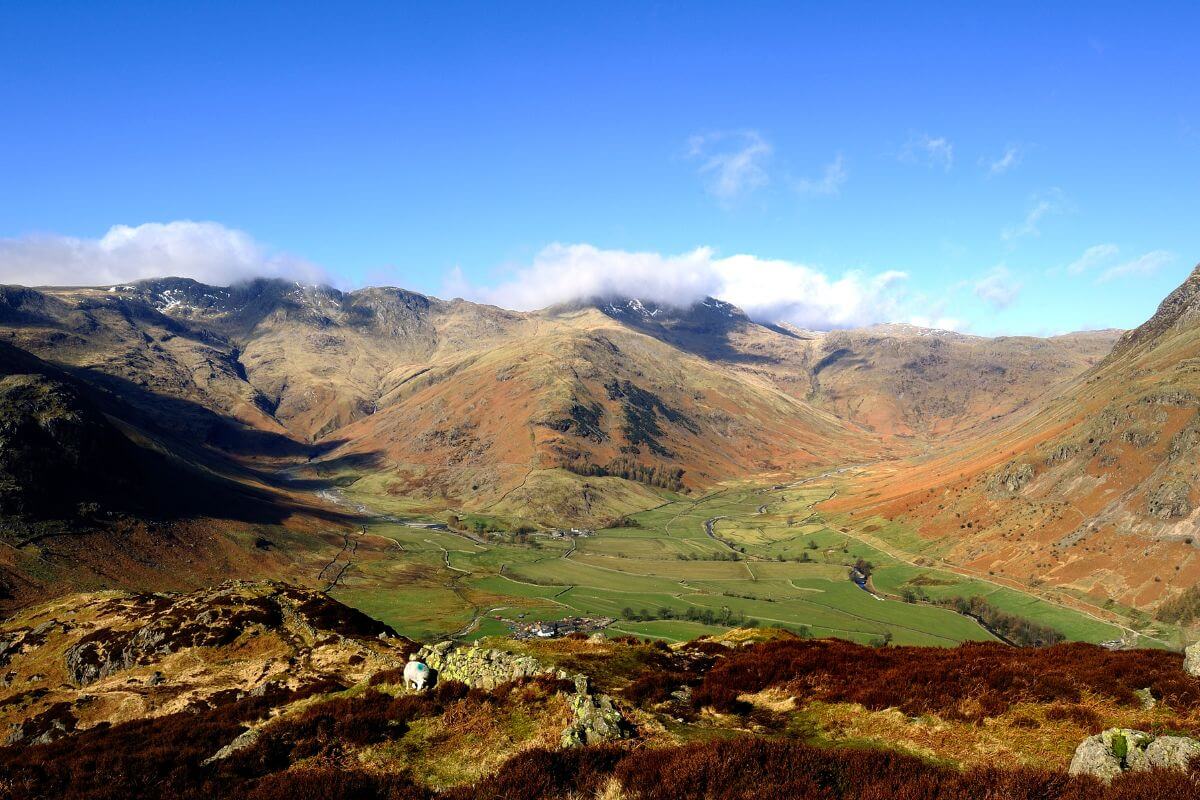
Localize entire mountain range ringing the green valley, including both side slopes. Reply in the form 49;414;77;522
0;268;1200;607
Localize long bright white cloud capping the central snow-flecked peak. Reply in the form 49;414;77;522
446;245;921;330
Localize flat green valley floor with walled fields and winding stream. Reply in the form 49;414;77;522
321;472;1161;645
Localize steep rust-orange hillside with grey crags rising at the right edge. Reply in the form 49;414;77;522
829;270;1200;608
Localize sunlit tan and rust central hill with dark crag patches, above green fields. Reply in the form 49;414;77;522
328;309;882;517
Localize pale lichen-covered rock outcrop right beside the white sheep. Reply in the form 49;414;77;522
415;642;630;747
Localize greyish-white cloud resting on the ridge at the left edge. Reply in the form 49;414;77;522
0;221;326;285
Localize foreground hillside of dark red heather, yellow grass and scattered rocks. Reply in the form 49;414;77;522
0;583;1200;800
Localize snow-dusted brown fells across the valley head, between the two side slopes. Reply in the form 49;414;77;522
0;278;1111;523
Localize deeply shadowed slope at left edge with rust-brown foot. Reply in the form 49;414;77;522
0;342;343;609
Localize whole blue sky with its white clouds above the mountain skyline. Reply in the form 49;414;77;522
0;2;1200;333
